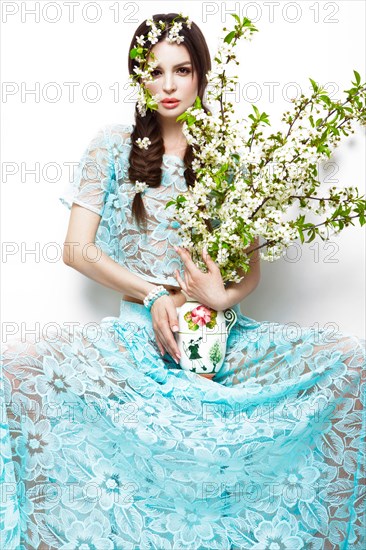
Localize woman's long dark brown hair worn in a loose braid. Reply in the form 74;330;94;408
128;13;211;231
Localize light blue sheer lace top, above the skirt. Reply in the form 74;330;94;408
59;124;188;287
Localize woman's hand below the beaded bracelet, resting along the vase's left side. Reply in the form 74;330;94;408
150;294;184;364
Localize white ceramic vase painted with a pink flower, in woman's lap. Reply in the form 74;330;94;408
175;300;237;374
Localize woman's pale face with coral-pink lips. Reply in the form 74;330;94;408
145;40;198;120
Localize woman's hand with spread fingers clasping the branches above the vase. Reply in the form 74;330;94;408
174;246;227;311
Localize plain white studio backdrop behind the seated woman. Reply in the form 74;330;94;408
1;1;365;341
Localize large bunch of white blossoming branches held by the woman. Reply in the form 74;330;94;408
166;14;366;282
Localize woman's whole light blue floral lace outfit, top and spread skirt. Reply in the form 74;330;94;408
0;124;366;550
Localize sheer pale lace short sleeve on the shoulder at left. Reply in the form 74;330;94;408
59;127;113;216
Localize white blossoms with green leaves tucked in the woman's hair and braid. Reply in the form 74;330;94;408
130;13;192;195
